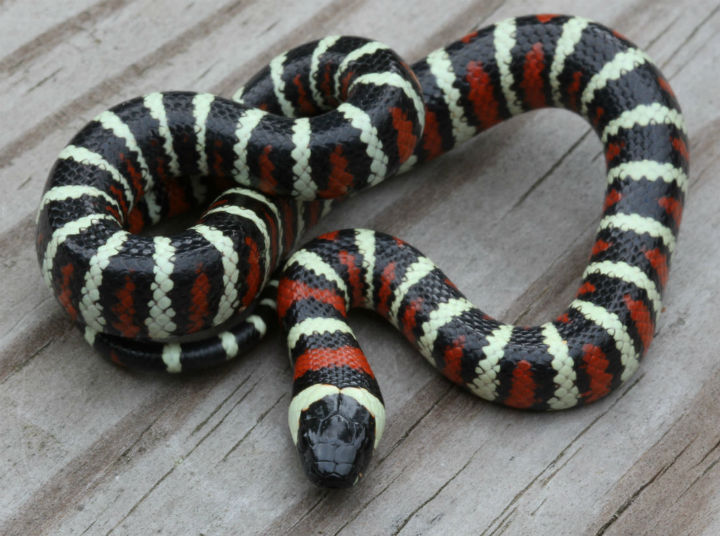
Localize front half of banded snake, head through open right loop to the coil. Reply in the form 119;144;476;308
278;15;688;486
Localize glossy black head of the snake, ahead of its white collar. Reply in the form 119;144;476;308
297;393;376;488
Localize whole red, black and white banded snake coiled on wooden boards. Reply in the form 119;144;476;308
37;15;689;487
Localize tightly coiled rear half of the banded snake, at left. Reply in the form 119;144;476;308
37;37;425;372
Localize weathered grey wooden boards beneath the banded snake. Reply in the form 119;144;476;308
0;0;720;536
